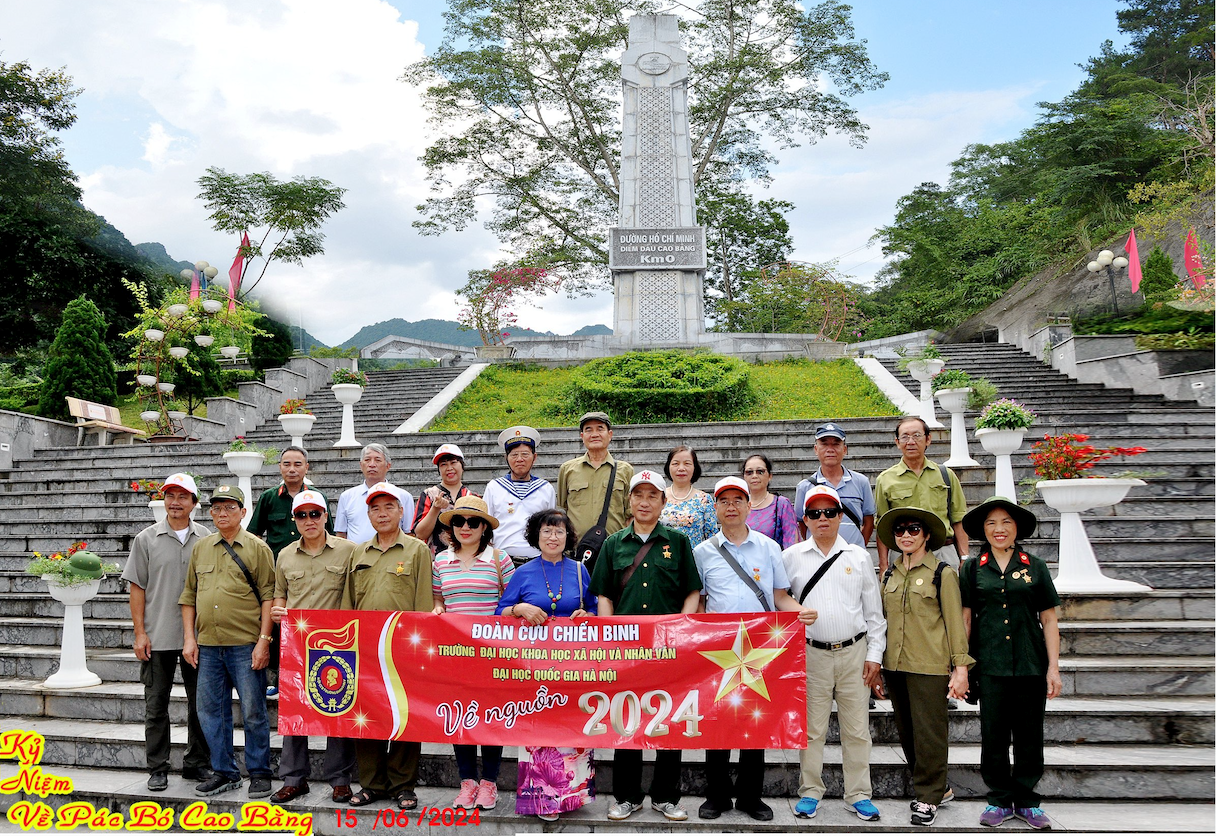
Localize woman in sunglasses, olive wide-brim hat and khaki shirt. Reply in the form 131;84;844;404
878;508;975;827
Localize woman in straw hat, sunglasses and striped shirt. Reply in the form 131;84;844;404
432;496;516;809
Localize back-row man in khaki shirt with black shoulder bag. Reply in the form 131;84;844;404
557;412;634;537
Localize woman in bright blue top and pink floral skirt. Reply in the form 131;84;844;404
499;508;596;821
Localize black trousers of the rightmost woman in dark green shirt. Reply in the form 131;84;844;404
980;676;1047;807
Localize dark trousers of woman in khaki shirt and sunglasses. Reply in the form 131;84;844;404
883;671;950;804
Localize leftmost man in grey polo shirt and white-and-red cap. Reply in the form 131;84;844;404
123;473;212;792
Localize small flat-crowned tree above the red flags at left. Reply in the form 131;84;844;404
198;168;347;295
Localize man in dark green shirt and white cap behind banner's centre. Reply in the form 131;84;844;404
589;470;700;821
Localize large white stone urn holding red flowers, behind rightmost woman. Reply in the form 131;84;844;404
1036;479;1152;593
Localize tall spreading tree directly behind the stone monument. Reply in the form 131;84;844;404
405;0;886;289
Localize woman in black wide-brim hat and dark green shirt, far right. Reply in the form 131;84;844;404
959;497;1063;829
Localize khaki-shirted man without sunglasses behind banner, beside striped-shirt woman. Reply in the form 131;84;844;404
344;482;434;809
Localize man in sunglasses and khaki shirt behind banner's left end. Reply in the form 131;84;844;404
263;490;355;804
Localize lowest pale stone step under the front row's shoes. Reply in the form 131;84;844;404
16;767;1214;836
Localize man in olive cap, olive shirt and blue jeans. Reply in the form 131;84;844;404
178;485;275;798
